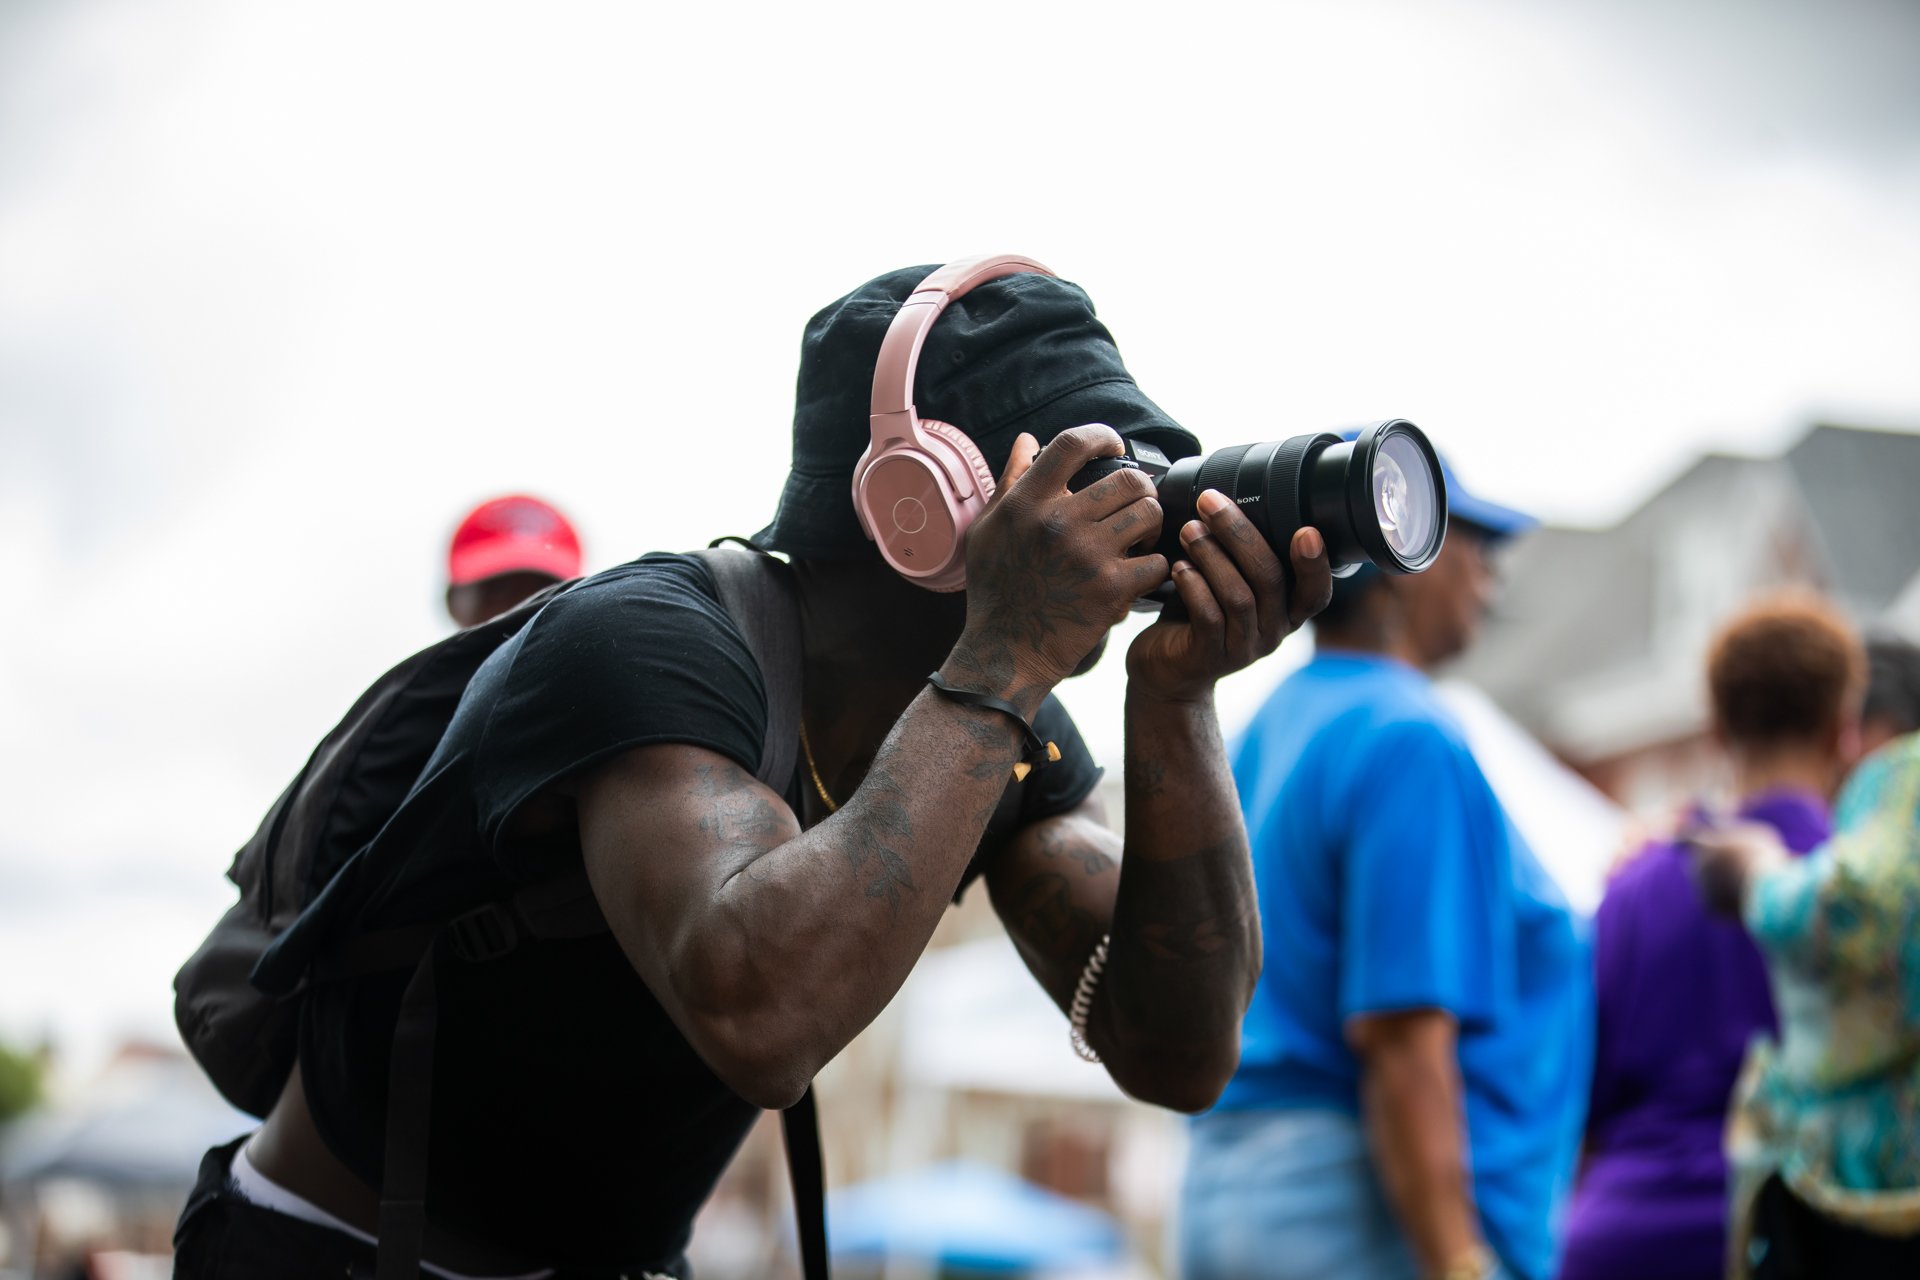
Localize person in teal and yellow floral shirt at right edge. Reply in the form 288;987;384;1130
1693;733;1920;1280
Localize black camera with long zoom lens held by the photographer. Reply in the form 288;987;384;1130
1068;418;1446;608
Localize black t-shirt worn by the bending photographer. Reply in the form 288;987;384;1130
269;555;1100;1270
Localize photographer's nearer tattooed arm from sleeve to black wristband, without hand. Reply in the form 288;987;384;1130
578;695;1018;1107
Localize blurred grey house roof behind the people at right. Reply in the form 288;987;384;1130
1452;426;1920;764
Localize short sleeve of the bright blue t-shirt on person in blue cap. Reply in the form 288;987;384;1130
1340;723;1513;1023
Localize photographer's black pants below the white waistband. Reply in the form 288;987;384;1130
173;1134;693;1280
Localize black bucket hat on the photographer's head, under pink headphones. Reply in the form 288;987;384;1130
755;267;1200;560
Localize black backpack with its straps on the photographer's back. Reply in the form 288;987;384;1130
173;539;828;1280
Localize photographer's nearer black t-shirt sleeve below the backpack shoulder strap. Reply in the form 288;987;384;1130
455;557;766;850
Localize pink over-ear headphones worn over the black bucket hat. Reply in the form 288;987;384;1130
852;253;1054;591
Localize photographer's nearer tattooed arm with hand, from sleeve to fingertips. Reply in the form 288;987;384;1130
576;428;1165;1107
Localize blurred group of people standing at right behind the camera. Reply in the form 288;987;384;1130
1181;478;1920;1280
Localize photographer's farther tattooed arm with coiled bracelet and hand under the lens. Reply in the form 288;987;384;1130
987;491;1332;1111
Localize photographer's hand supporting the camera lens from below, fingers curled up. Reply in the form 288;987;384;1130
1127;489;1332;699
